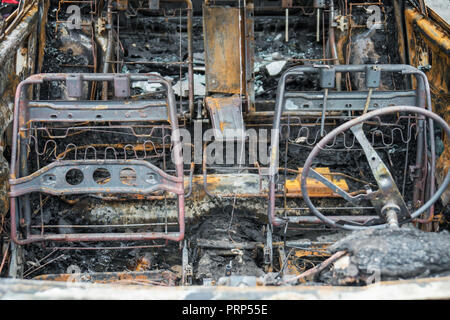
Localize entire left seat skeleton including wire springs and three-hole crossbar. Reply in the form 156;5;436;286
9;74;185;245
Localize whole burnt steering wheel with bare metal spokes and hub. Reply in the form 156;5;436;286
301;106;450;230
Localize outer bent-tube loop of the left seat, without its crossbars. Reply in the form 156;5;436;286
9;74;185;245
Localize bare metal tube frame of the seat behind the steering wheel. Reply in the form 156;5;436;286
268;64;436;226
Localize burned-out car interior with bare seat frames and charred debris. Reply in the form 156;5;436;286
0;0;450;298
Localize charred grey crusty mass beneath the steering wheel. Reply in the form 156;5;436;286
321;227;450;285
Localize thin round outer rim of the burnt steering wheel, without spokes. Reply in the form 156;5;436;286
300;106;450;231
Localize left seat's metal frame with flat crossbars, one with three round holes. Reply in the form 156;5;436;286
9;74;185;245
